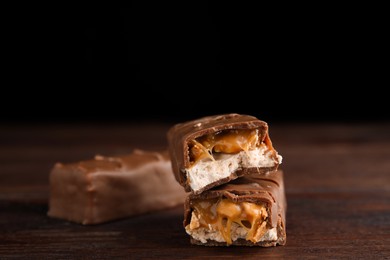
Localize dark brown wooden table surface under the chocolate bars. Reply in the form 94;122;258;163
0;122;390;259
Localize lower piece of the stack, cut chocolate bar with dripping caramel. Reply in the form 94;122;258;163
183;170;287;247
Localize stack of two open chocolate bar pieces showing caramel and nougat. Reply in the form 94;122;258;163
167;114;286;247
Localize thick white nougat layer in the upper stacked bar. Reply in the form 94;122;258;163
186;145;282;191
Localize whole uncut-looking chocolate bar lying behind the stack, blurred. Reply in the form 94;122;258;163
48;150;186;225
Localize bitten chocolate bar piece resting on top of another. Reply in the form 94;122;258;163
167;114;282;194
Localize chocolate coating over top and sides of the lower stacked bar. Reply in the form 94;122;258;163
183;170;287;230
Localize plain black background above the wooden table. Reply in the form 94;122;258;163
0;5;390;123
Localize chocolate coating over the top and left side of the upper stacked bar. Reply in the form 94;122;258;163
167;114;268;190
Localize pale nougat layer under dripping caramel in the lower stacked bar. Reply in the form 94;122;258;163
186;223;278;243
